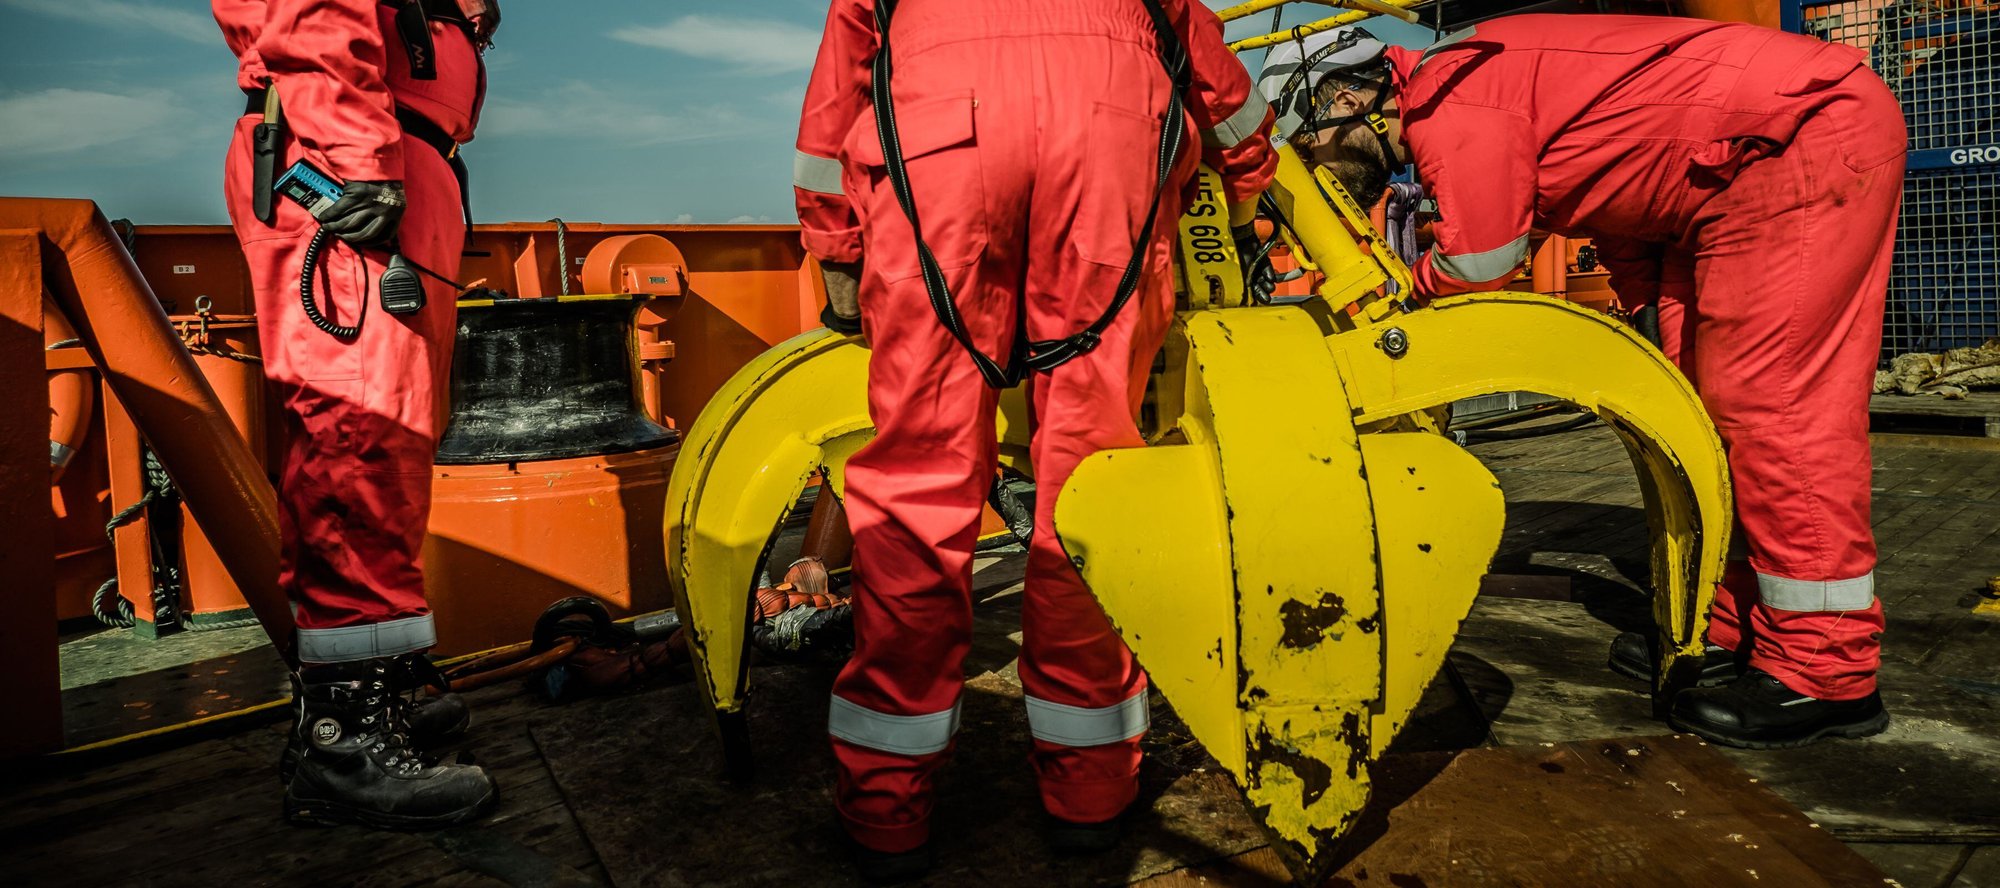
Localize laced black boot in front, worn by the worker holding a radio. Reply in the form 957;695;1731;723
284;658;498;830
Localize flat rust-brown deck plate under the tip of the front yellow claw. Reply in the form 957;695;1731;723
1140;736;1884;888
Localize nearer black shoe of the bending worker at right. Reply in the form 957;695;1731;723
1668;668;1888;750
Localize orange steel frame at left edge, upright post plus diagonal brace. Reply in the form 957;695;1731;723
0;198;292;756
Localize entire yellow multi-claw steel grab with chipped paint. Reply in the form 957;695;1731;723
666;148;1732;880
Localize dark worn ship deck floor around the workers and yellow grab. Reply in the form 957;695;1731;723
0;428;2000;888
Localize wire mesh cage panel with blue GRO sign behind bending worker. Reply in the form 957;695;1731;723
1784;0;2000;362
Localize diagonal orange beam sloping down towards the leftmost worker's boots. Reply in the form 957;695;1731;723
0;198;298;664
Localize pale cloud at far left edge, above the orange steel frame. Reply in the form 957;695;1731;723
0;88;190;162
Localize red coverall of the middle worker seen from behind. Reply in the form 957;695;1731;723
794;0;1276;852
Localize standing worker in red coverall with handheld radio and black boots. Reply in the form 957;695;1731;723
214;0;500;828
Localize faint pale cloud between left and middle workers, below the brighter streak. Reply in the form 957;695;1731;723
480;82;768;146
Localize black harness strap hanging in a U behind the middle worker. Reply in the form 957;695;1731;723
870;0;1192;388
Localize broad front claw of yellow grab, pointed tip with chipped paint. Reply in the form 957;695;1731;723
1056;308;1502;874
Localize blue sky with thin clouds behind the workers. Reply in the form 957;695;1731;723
0;0;1428;222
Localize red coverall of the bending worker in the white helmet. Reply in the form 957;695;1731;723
1390;16;1906;700
